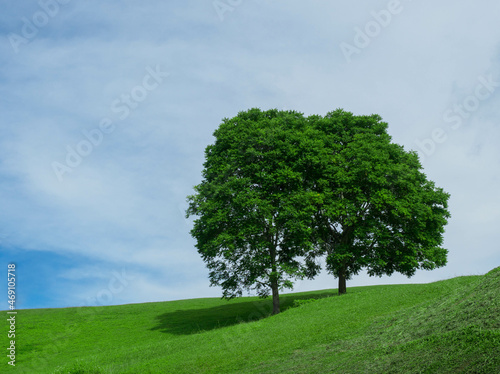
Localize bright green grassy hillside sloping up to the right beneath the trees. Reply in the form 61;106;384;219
4;268;500;374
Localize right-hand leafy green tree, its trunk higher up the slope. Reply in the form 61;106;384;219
308;110;450;294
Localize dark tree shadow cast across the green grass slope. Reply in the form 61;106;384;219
151;291;336;335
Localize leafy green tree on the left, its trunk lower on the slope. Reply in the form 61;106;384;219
187;109;321;314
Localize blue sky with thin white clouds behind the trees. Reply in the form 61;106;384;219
0;0;500;309
